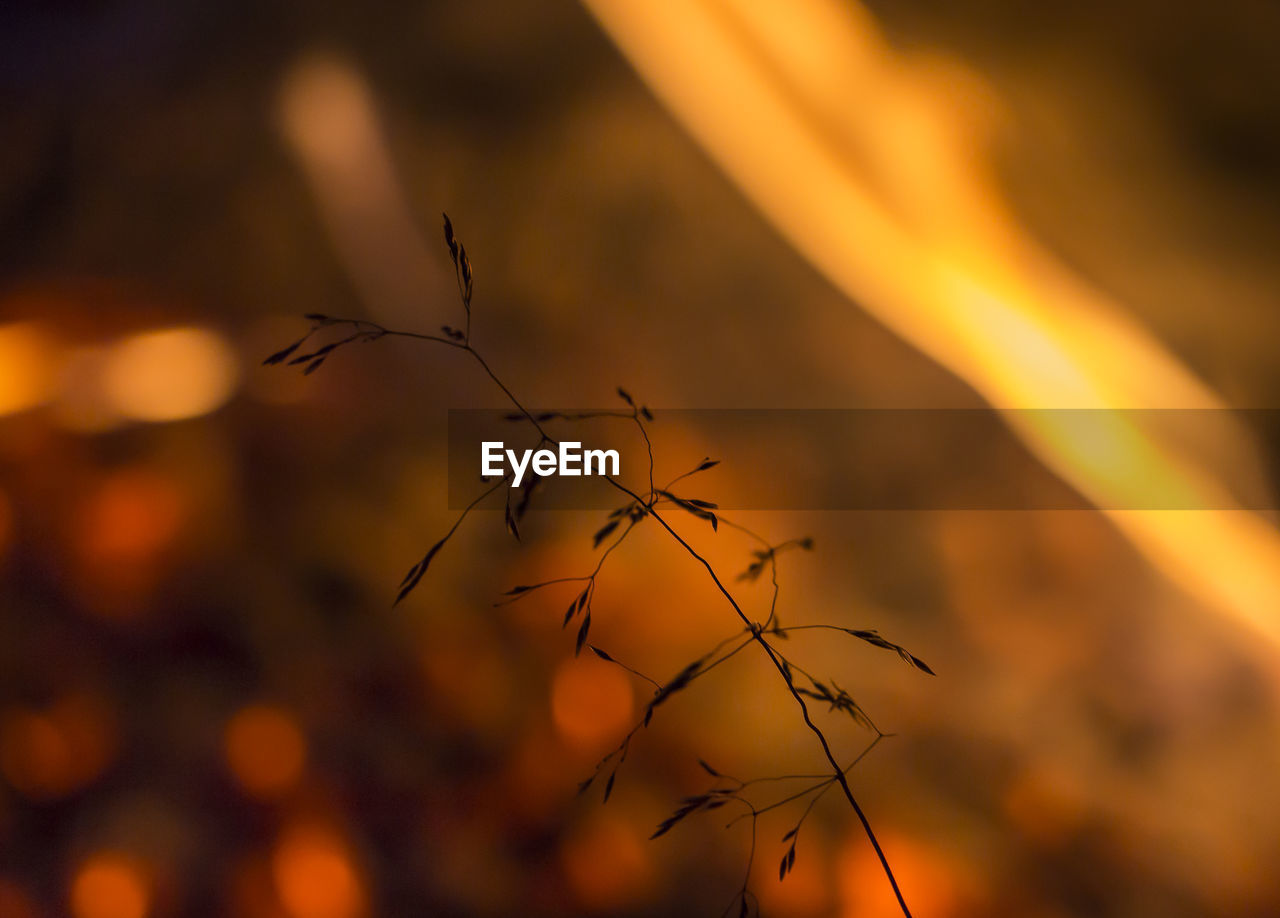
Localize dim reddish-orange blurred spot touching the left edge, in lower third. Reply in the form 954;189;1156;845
0;695;115;800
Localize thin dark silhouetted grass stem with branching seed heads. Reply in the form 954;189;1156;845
264;215;933;918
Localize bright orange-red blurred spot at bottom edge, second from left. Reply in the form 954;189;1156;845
271;826;366;918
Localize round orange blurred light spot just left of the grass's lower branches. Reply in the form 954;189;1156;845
552;656;635;746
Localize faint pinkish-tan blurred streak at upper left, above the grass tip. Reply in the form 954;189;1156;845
279;54;443;323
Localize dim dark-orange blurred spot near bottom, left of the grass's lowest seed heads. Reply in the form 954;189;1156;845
561;813;653;912
